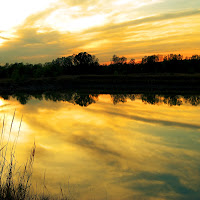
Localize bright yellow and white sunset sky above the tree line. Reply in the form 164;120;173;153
0;0;200;64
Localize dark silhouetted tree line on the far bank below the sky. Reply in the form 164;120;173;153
0;52;200;81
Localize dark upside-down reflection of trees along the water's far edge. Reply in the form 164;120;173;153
0;92;200;107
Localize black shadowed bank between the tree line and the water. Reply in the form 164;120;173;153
0;74;200;95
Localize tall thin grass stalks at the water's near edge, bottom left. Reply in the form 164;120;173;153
0;112;76;200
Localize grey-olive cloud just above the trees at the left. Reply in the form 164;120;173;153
0;28;81;63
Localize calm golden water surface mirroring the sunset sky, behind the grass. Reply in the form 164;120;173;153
0;94;200;200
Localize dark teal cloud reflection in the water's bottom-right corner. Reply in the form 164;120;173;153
116;172;199;199
